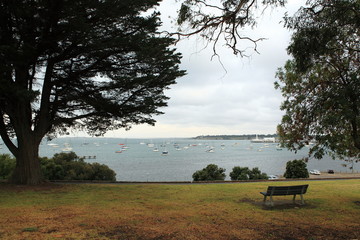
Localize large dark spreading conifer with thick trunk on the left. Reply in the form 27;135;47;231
0;0;184;184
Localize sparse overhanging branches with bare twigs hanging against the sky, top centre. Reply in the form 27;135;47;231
174;0;285;56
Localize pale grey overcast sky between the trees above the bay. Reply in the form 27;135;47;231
105;0;303;138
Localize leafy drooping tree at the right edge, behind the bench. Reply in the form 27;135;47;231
276;0;360;158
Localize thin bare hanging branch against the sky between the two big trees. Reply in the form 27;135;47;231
164;0;278;57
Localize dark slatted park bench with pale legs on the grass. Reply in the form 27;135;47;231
260;185;309;206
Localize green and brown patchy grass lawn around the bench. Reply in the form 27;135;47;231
0;180;360;240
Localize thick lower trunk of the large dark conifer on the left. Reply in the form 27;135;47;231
10;138;43;185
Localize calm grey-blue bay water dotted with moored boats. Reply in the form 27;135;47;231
0;138;360;181
